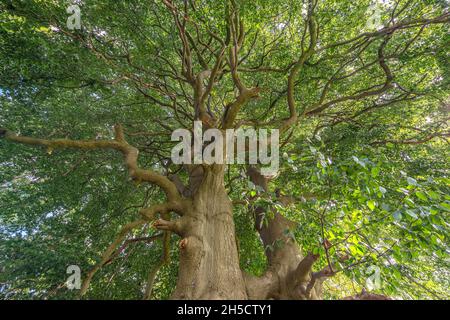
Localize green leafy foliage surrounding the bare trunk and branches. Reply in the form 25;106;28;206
0;0;450;299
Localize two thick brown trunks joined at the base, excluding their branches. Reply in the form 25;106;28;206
164;165;327;299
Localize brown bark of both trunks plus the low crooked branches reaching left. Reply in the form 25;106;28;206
0;130;387;300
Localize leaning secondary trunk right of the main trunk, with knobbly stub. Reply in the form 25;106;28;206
245;167;332;300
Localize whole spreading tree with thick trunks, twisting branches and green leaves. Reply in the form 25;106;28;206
0;0;450;299
